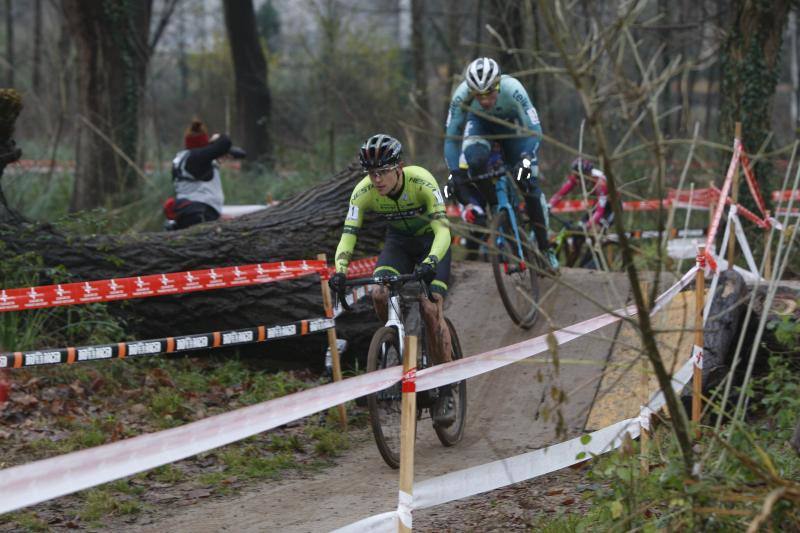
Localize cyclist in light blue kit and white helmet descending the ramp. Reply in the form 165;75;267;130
444;57;558;270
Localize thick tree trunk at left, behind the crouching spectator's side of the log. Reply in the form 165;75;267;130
63;0;152;211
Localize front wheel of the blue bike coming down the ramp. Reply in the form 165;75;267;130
489;210;539;329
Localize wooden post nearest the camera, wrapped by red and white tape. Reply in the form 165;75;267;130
397;336;417;533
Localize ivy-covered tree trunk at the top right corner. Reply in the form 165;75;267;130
720;0;791;210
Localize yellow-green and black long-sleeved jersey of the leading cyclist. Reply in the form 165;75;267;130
336;166;450;272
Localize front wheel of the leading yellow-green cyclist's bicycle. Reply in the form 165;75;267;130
367;328;403;468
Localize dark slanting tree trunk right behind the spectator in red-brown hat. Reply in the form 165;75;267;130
224;0;270;166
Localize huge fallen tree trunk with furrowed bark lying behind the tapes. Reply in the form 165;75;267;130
0;92;384;366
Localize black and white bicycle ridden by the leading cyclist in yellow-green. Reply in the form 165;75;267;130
337;274;467;468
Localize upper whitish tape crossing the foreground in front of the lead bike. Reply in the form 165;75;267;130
0;267;696;516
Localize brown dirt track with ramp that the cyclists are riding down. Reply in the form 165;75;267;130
120;263;644;532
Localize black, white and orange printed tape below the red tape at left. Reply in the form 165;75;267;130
0;318;334;368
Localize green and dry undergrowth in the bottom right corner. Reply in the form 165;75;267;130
533;355;800;531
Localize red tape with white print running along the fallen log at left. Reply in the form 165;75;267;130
0;260;327;312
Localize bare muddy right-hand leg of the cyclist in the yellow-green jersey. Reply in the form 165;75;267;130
420;244;453;364
